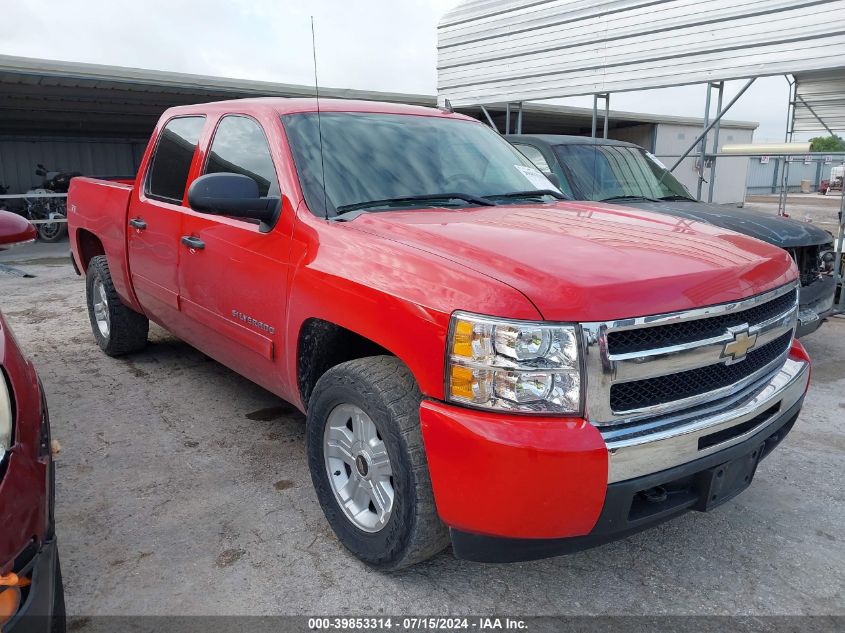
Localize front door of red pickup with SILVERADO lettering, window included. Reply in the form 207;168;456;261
179;114;292;392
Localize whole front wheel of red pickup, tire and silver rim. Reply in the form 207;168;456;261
306;356;449;569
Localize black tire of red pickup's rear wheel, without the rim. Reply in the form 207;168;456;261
85;255;150;356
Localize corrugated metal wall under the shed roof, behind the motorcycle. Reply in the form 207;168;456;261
0;137;147;193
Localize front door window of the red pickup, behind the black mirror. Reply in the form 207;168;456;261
204;115;280;197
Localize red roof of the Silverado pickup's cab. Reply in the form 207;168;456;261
165;97;476;121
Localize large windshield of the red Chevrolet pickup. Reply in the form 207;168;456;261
282;112;555;216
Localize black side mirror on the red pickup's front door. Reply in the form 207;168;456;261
188;173;281;231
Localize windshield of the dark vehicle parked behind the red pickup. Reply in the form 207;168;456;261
555;145;694;201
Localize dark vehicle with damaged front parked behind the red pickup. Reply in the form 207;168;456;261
505;135;835;336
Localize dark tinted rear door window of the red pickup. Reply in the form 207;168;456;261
147;116;205;204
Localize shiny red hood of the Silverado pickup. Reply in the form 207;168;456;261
350;202;797;321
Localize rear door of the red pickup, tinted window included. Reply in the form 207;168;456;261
126;116;206;327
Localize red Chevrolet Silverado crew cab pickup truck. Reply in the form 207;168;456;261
68;99;810;568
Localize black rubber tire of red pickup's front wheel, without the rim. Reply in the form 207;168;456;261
306;356;449;569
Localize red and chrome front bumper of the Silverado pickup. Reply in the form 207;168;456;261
420;343;810;562
